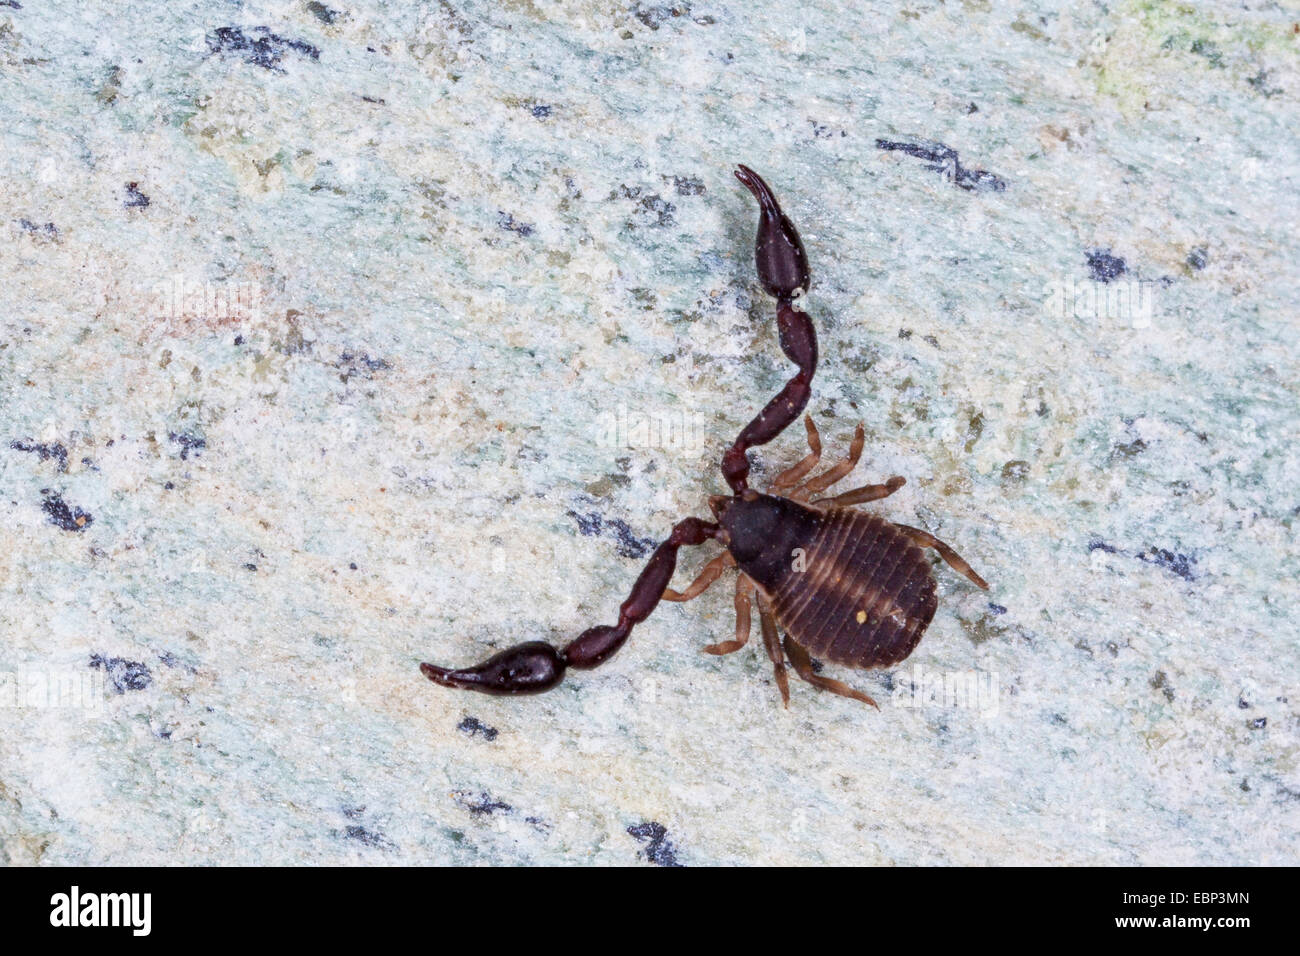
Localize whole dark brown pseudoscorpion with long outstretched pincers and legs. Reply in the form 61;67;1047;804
420;166;988;706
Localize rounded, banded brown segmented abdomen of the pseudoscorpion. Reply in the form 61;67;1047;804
772;510;936;667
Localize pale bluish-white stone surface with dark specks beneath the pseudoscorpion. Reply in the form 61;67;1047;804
0;0;1300;865
